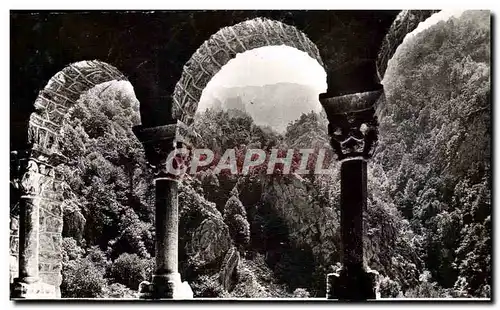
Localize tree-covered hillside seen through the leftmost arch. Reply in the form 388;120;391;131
59;82;154;297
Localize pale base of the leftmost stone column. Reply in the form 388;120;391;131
10;277;60;299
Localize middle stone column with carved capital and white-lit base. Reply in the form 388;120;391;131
134;122;193;299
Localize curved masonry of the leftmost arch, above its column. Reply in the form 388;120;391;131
28;60;127;154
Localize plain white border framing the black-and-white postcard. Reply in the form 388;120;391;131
0;0;500;309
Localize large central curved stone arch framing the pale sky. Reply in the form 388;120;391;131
172;18;324;125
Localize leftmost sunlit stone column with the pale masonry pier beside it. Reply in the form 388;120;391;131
11;149;62;299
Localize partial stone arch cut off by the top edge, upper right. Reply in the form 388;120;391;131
377;10;439;81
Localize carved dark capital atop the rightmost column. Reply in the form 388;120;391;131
319;86;383;160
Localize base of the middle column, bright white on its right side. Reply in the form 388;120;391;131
139;273;193;299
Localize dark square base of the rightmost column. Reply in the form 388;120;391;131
326;269;378;301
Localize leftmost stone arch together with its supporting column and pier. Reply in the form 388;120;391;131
10;60;132;298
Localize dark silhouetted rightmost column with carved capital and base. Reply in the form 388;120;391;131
320;85;383;300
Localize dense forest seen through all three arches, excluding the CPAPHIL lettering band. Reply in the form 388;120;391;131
30;12;492;298
